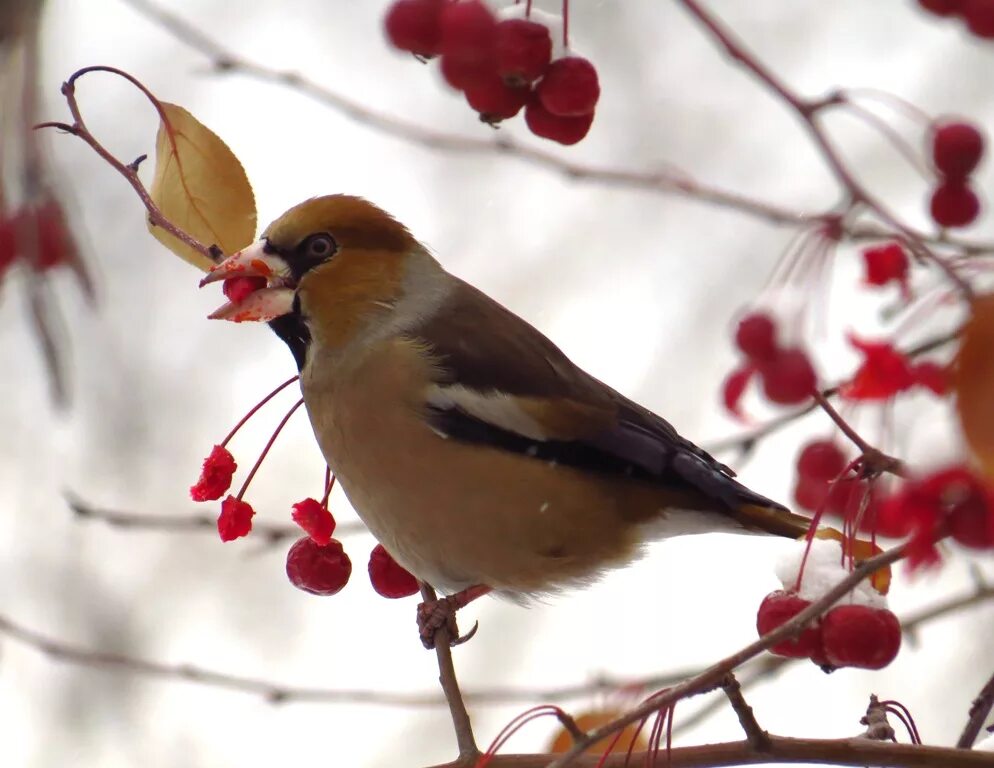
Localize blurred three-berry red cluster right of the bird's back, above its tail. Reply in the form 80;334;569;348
724;312;818;416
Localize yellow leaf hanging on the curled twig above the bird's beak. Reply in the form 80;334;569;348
148;102;256;272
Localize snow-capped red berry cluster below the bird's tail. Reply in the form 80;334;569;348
756;536;901;669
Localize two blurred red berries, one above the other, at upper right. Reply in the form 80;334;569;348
929;118;994;227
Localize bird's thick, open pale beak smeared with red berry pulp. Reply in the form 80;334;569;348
200;241;294;323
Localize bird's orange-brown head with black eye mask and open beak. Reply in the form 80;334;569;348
200;195;428;362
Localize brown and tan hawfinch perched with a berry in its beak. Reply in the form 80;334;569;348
201;194;810;647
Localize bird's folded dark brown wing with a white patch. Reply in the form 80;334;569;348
410;281;779;511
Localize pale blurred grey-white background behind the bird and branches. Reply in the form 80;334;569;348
0;0;994;768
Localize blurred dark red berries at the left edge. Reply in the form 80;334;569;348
0;197;78;277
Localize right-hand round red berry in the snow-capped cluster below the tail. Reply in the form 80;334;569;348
821;605;901;669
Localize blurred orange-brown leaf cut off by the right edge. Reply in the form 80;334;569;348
953;293;994;478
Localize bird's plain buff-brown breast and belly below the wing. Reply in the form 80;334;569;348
301;339;659;594
